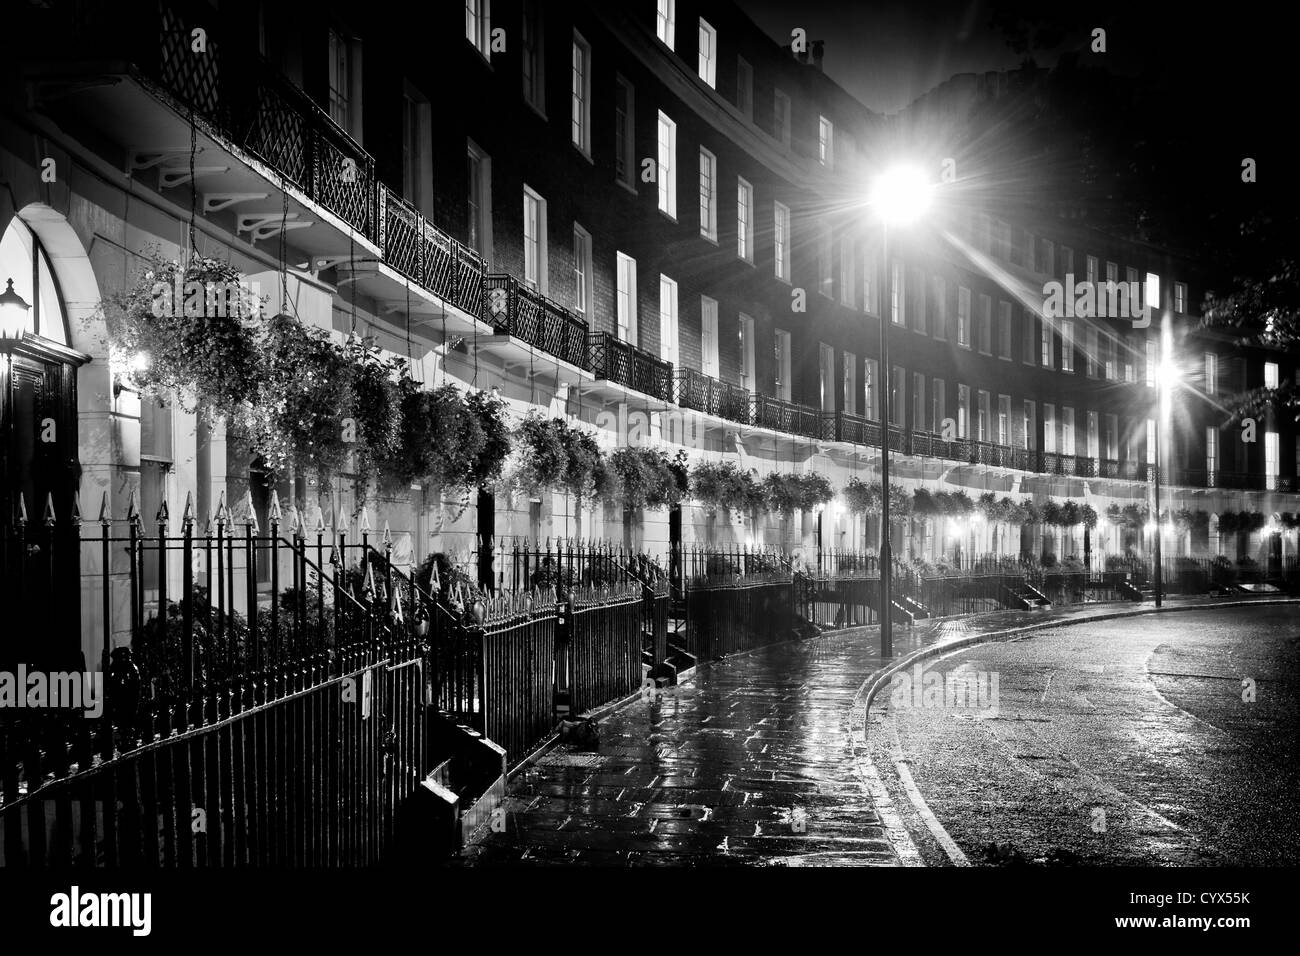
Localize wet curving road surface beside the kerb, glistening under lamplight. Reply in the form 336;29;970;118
867;605;1300;865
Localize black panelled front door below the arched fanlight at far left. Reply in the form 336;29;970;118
0;337;83;670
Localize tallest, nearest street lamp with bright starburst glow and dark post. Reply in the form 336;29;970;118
871;166;932;657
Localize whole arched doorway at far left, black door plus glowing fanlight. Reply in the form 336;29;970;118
0;216;90;670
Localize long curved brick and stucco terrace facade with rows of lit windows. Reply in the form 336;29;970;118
0;0;1300;658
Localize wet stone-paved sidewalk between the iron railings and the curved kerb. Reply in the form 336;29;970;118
462;605;1295;866
